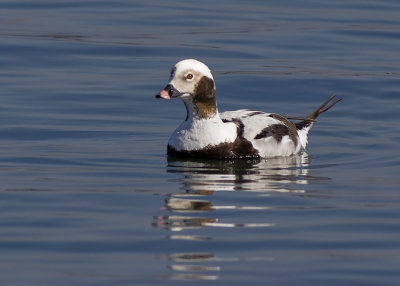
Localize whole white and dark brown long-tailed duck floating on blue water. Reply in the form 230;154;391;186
156;59;341;159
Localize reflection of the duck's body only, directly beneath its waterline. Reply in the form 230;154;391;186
167;153;309;192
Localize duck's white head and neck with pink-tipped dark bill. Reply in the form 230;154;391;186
156;59;217;118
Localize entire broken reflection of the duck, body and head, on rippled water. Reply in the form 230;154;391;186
154;153;311;280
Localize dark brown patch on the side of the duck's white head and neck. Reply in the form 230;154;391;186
193;76;217;118
